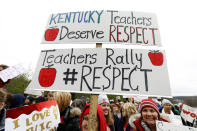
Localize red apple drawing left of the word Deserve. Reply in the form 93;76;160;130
44;27;59;41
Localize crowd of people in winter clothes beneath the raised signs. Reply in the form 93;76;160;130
0;89;194;131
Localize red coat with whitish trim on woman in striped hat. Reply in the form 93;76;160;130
129;114;170;131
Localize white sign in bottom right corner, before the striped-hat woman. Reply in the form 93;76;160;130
156;121;197;131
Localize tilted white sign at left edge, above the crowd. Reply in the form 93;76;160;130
0;64;26;82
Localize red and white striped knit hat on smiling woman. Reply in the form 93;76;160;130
140;99;160;115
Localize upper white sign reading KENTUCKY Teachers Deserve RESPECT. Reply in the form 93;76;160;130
42;10;161;46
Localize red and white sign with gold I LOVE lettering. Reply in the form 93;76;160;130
5;100;60;131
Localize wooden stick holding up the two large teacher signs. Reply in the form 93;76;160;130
88;43;102;131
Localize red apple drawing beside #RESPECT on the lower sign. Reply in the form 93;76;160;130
38;68;56;87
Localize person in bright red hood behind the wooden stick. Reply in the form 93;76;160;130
80;104;110;131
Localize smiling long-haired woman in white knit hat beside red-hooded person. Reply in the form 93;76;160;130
98;94;115;131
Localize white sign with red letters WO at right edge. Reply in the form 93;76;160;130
181;104;197;123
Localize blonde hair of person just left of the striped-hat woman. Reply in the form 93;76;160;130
123;102;137;117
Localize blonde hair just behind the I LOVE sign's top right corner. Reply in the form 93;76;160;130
53;92;71;112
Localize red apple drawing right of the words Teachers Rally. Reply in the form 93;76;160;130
148;50;163;66
